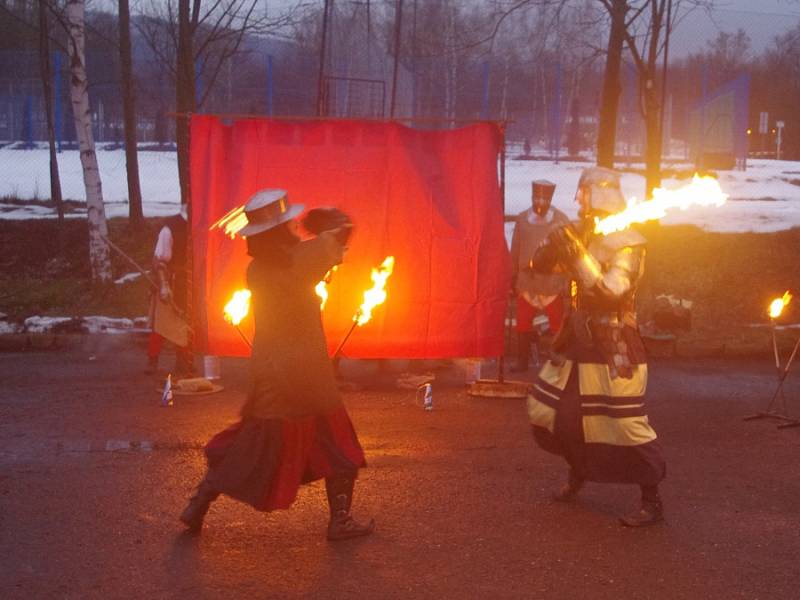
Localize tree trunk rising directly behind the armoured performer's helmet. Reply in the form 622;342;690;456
597;0;628;169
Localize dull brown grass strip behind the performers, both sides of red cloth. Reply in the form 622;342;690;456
0;219;800;355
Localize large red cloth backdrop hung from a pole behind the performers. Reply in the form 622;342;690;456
191;116;510;358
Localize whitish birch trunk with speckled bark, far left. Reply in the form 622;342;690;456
66;0;111;284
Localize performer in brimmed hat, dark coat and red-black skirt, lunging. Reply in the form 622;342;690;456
180;190;374;540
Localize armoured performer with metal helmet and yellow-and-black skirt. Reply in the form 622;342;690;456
528;167;666;527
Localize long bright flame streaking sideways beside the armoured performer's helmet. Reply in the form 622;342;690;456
594;174;728;235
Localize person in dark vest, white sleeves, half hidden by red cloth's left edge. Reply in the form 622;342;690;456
145;205;194;377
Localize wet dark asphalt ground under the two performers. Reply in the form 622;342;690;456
0;335;800;599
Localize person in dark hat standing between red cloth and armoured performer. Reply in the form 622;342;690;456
511;180;569;372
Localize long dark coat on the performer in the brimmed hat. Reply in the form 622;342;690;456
242;232;344;419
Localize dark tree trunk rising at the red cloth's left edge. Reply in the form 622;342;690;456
175;0;195;205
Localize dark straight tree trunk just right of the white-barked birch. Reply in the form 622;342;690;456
119;0;144;228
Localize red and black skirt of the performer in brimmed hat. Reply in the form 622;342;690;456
205;408;366;511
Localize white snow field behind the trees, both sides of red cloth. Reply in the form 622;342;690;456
0;147;800;232
